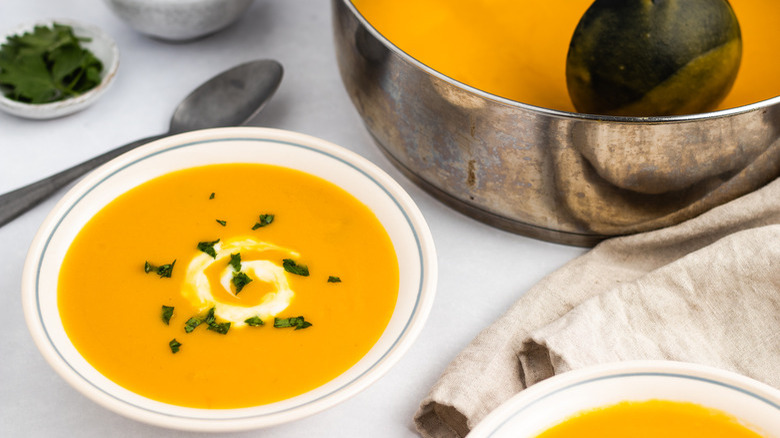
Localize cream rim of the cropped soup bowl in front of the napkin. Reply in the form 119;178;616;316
468;361;780;438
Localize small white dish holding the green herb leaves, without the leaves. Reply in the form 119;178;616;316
0;19;119;119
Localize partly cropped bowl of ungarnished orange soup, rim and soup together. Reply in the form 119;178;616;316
469;361;780;438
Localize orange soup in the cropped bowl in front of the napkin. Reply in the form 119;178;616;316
537;400;761;438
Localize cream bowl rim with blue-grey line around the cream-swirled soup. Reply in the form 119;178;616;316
22;128;438;431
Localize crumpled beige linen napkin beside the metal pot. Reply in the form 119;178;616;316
415;180;780;438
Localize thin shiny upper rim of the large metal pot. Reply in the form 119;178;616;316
335;0;780;124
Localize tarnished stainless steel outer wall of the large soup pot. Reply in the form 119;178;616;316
331;0;780;246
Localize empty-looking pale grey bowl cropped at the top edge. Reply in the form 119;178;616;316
105;0;253;41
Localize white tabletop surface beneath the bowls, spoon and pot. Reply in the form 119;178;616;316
0;0;585;438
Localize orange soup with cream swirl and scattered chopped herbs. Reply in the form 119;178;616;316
58;164;399;408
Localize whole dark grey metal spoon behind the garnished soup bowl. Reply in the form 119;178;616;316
0;60;283;226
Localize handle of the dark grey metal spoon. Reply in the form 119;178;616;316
0;134;167;227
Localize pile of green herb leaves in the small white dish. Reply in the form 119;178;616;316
0;23;103;104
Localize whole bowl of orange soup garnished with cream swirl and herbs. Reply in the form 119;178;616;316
22;128;437;431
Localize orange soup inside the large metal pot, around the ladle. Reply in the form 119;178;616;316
352;0;780;112
